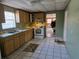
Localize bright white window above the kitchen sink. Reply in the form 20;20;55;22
2;10;16;29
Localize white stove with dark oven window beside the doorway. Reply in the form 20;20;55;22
34;27;44;39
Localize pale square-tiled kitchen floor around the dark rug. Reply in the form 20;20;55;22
5;37;70;59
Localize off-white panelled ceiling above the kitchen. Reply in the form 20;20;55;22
1;0;69;12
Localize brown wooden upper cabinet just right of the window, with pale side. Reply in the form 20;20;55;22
16;10;29;24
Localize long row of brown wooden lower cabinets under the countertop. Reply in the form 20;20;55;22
0;29;33;57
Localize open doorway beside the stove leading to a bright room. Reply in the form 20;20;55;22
46;13;56;37
